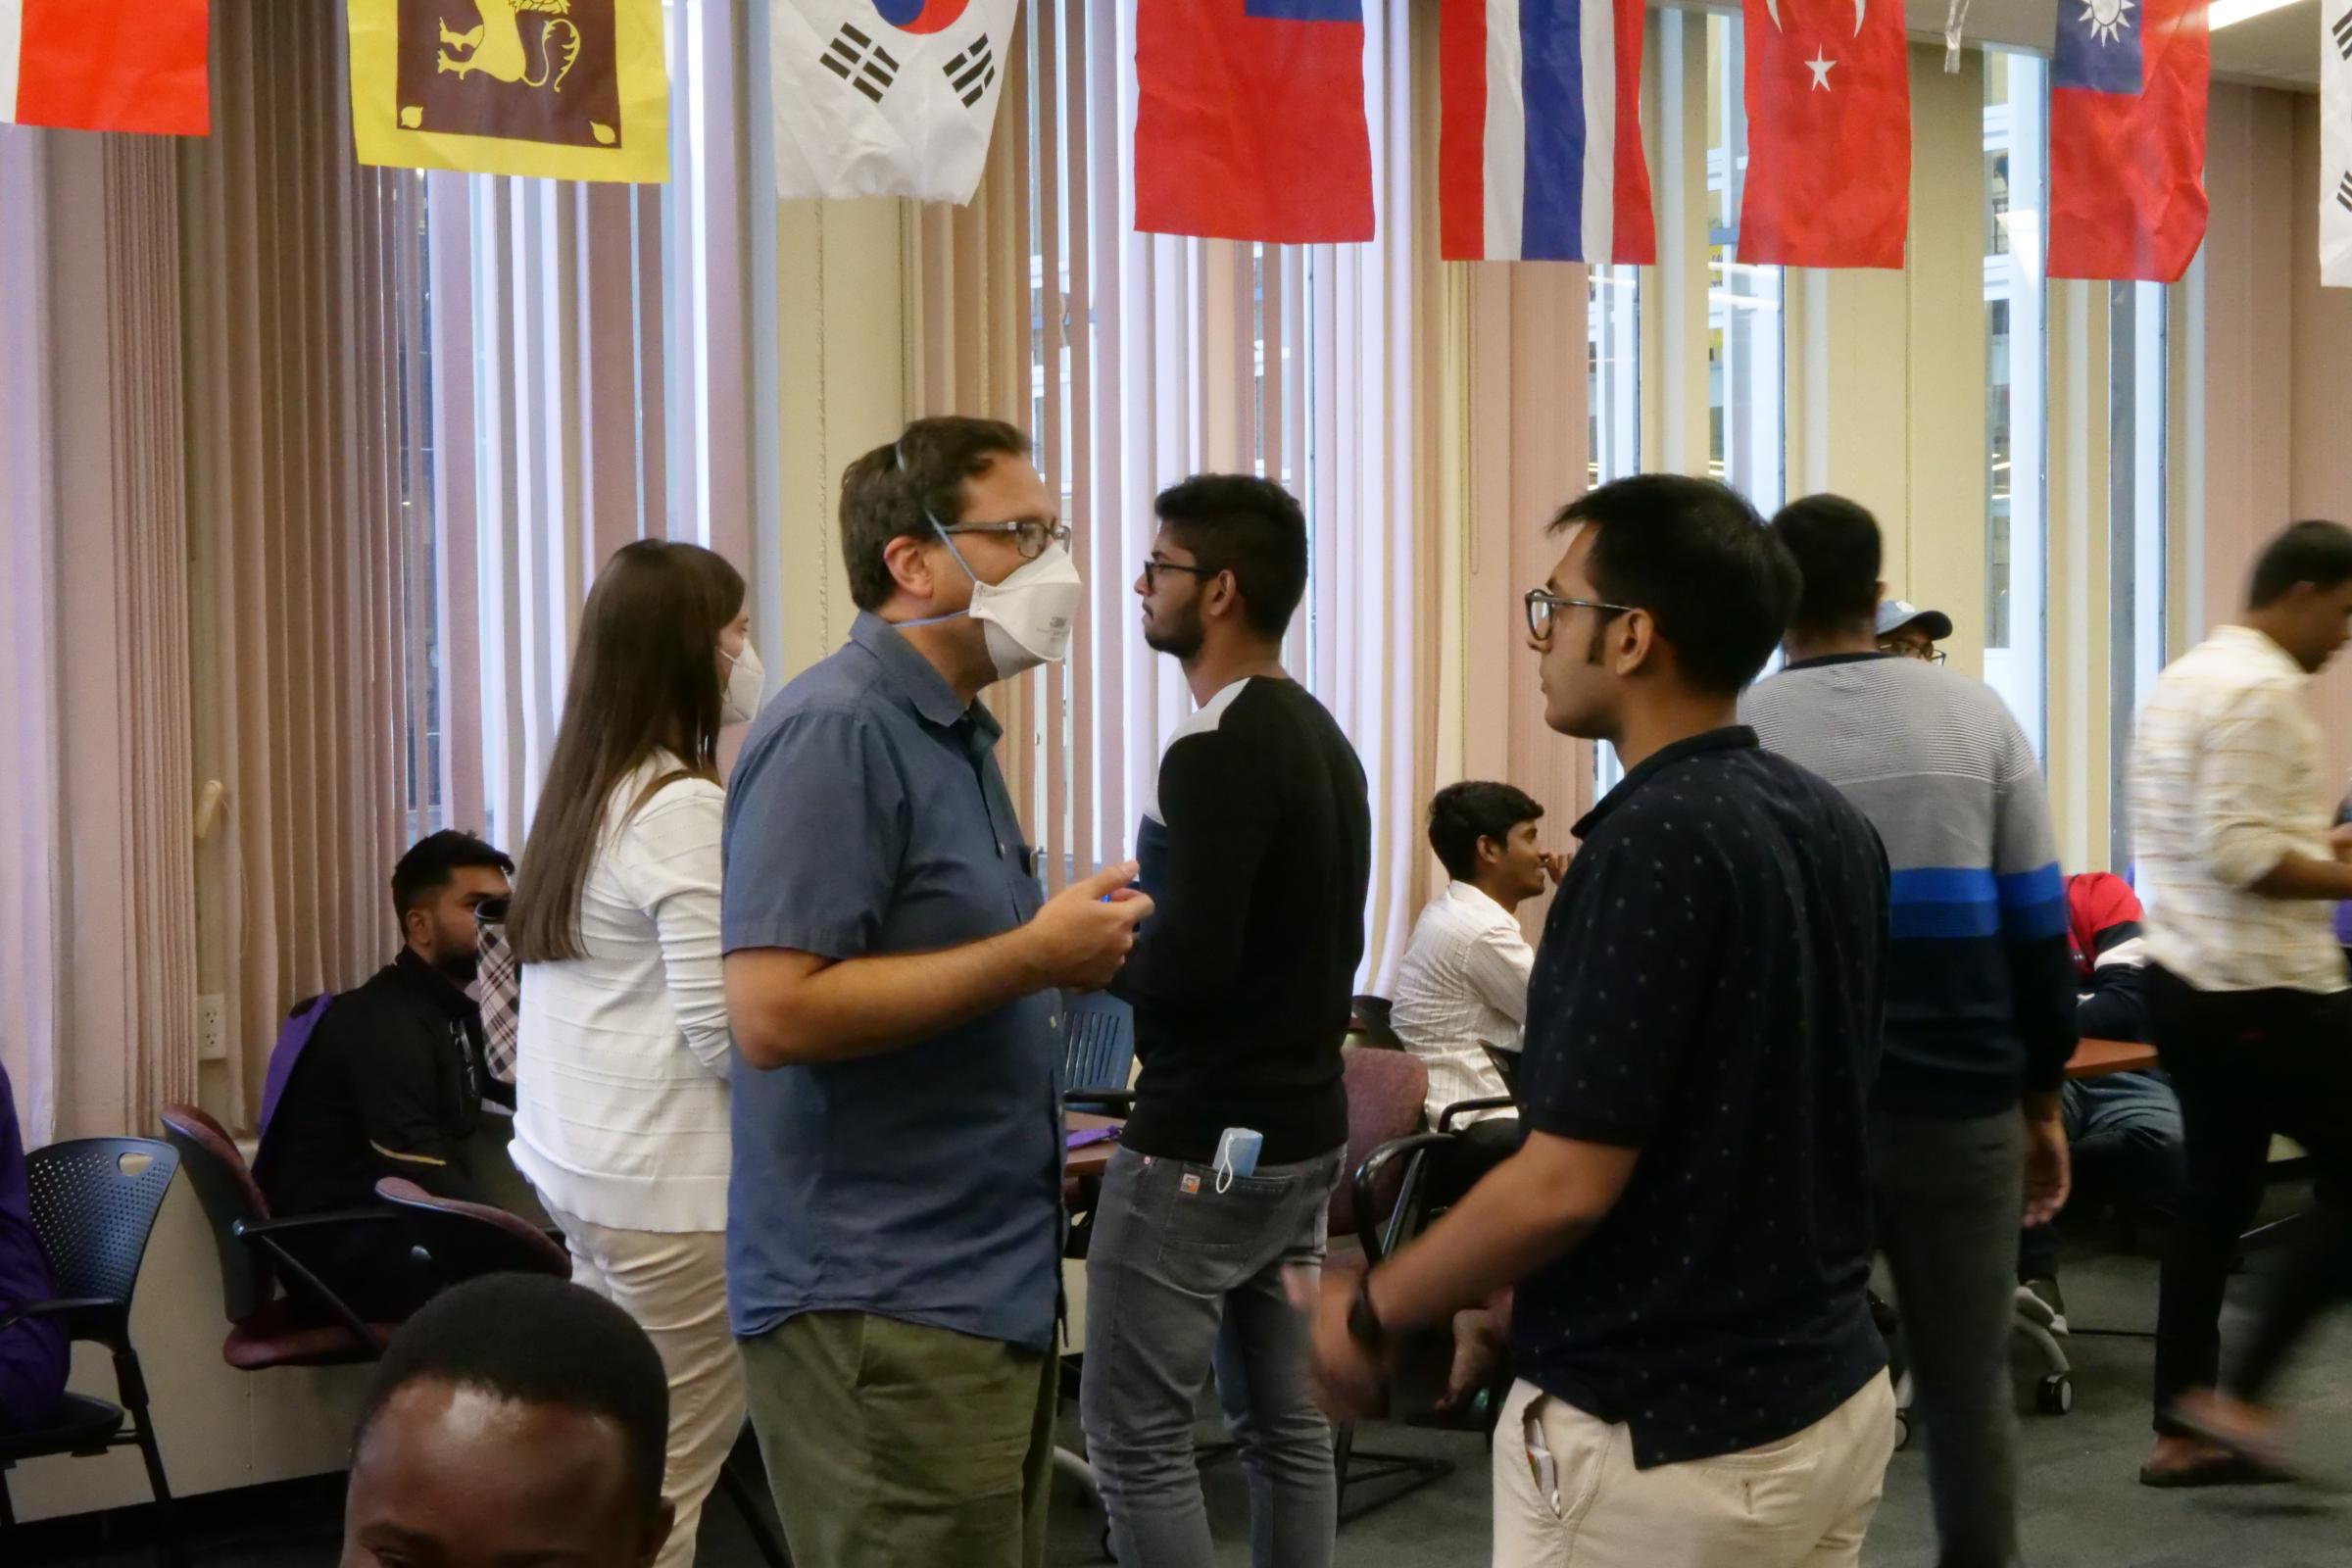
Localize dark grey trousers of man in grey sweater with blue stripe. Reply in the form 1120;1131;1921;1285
1870;1109;2025;1568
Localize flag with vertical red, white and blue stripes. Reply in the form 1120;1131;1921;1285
1437;0;1658;264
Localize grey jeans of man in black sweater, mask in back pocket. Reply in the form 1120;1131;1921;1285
1080;1150;1346;1568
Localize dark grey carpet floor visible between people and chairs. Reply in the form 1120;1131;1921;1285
25;1187;2352;1568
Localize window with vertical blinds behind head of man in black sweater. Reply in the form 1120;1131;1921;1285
1002;0;1428;980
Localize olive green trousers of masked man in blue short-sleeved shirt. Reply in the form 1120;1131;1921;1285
739;1312;1060;1568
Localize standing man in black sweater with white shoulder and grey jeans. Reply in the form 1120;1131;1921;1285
1082;475;1371;1568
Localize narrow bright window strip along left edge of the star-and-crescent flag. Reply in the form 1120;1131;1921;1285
1707;12;1788;517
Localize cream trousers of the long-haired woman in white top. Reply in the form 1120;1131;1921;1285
548;1208;743;1568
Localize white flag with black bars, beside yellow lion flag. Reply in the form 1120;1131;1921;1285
769;0;1021;202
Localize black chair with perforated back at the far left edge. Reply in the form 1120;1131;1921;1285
0;1138;186;1568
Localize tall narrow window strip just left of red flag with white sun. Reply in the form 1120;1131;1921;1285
1985;49;2048;757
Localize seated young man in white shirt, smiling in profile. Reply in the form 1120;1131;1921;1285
1388;780;1566;1197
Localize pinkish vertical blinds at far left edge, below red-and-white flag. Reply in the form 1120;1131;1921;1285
0;127;195;1143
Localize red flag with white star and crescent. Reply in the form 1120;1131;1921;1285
1740;0;1910;268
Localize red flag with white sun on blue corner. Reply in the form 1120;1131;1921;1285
2048;0;2211;282
